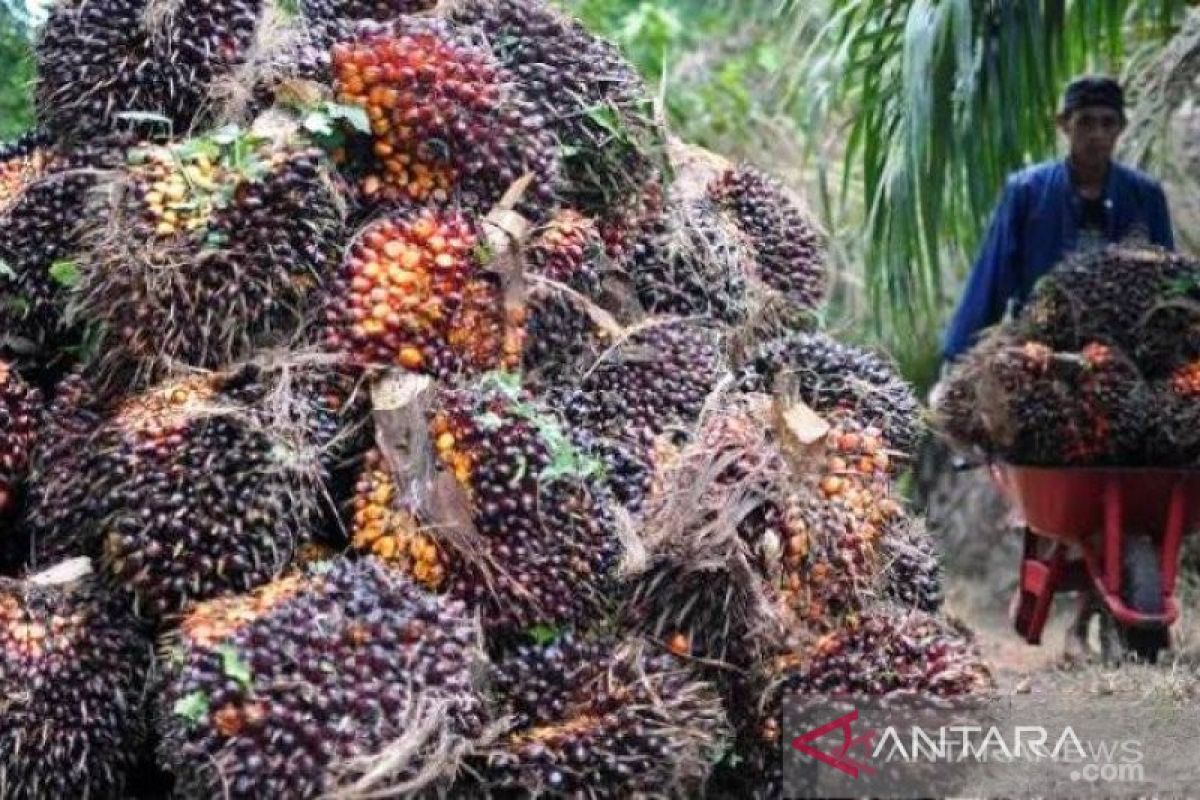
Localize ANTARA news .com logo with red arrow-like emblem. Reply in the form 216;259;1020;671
791;709;1144;781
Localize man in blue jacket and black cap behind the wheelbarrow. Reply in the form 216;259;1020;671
935;77;1175;657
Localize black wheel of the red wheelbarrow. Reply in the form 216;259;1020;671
1100;536;1171;663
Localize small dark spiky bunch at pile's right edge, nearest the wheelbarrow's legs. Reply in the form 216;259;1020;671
880;517;943;614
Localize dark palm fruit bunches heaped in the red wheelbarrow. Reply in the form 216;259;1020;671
935;241;1200;468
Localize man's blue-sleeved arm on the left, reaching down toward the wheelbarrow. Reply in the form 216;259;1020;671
942;178;1024;361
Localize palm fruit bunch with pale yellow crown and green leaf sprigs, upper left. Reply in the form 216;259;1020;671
72;128;342;388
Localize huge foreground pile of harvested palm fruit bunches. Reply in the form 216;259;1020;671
0;0;991;799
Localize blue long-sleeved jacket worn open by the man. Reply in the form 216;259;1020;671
942;161;1175;361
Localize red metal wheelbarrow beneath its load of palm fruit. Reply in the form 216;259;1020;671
991;464;1200;662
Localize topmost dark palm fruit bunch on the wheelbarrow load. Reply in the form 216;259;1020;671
1019;246;1200;377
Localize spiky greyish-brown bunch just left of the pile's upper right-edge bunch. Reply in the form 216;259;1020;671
628;193;754;324
